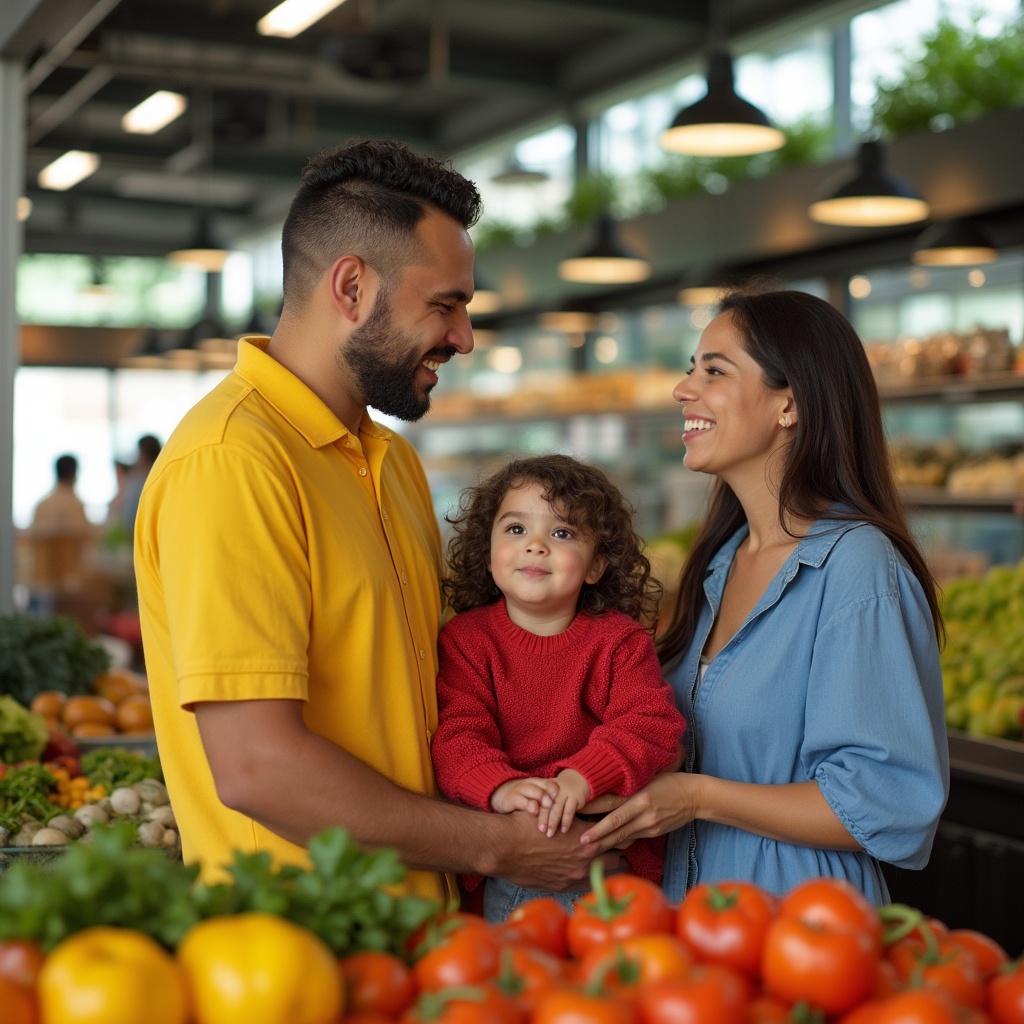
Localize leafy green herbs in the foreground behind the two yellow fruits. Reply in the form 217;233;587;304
0;822;438;956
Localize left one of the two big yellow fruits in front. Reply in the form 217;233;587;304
38;926;188;1024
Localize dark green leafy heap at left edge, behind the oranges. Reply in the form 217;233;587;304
0;614;111;707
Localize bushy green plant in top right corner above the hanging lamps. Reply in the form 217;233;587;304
872;17;1024;136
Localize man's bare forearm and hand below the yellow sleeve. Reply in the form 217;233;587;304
196;700;596;892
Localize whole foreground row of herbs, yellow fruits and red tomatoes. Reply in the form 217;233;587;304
0;828;1024;1024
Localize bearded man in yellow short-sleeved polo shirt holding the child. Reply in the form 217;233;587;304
135;141;595;899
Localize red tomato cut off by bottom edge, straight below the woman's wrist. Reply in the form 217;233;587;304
637;964;751;1024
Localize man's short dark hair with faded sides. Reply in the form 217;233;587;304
281;139;481;303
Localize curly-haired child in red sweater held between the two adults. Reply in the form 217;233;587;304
431;455;684;922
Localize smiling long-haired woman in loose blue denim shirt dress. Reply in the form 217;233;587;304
583;291;948;904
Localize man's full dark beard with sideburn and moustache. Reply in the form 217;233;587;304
338;294;456;421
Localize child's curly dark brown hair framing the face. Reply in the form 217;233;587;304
441;455;662;632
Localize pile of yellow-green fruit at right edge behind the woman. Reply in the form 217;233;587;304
942;560;1024;739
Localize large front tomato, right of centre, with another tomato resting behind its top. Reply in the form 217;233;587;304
761;916;879;1015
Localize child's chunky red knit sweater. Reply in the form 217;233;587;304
431;599;685;881
